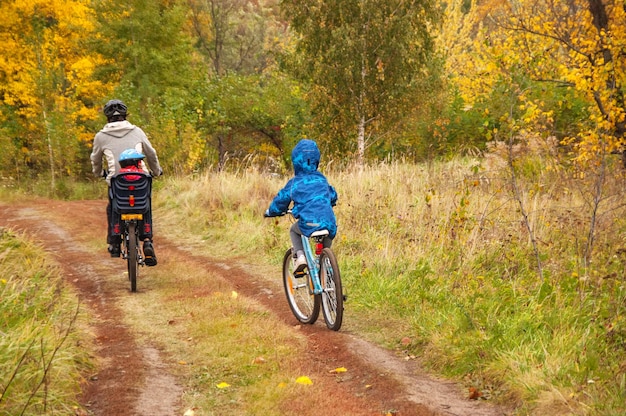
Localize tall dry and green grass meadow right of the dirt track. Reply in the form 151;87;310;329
155;155;626;415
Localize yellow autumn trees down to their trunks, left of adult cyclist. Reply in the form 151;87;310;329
0;0;107;182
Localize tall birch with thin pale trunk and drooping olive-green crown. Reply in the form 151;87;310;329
281;0;438;163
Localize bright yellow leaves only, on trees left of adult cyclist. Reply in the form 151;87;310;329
0;0;111;161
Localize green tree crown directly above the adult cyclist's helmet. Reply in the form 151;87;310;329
94;0;193;96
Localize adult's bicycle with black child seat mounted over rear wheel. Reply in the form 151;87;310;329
109;172;152;292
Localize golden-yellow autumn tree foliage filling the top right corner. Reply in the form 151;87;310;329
438;0;626;166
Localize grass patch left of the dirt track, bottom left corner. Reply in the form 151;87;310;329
0;228;91;415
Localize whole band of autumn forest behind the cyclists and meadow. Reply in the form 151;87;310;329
0;0;626;184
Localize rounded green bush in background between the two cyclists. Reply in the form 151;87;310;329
191;74;308;171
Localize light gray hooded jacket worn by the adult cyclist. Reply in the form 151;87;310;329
90;120;163;184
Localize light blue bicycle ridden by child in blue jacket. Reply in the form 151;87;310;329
283;211;345;331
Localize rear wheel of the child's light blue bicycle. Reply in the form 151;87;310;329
320;248;343;331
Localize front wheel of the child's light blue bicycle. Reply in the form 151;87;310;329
283;249;320;324
